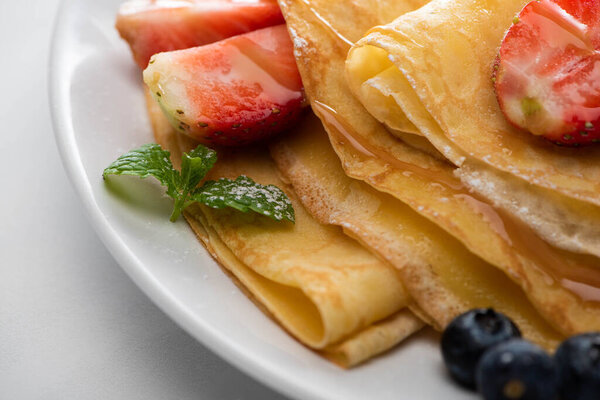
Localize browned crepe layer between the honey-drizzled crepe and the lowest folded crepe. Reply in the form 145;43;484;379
271;115;562;349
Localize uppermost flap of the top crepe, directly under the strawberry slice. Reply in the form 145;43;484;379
352;0;600;205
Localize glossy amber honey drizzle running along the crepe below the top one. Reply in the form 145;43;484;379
312;100;600;303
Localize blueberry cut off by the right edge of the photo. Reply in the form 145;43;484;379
554;333;600;400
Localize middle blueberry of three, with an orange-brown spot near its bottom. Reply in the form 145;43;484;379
477;339;570;400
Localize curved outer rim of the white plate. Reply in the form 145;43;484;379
47;0;327;400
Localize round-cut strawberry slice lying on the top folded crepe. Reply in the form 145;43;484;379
494;0;600;146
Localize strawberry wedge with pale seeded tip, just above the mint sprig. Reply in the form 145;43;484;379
144;25;304;146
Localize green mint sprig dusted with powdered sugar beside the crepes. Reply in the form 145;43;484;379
102;143;295;222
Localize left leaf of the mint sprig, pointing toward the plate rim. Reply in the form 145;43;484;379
102;143;180;198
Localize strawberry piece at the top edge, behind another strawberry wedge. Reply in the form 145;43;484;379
116;0;284;69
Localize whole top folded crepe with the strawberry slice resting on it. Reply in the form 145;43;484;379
347;1;600;256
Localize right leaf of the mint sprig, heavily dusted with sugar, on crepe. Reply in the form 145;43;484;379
192;175;295;222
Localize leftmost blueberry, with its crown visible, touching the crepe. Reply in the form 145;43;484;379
442;308;521;388
